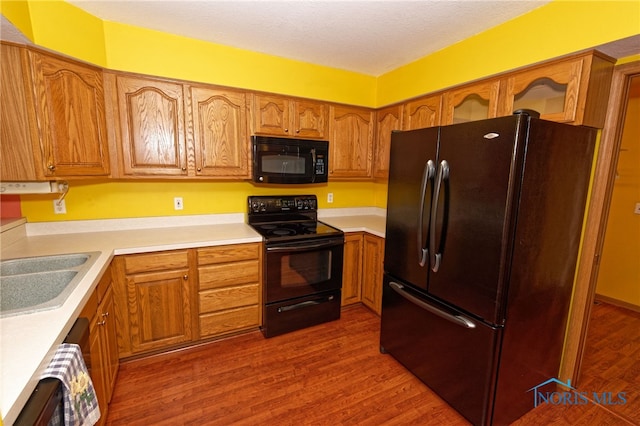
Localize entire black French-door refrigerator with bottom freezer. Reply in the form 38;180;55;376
380;113;596;425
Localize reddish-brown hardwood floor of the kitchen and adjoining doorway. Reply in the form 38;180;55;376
107;306;640;425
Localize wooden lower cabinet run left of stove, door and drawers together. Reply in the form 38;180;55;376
114;243;262;358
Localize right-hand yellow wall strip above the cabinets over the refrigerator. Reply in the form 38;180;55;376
377;0;640;107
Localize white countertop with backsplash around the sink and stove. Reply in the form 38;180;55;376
0;209;385;424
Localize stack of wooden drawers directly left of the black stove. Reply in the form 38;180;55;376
197;243;262;338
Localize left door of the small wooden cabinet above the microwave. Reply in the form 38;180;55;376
251;94;292;136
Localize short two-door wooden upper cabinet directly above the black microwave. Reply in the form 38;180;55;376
252;94;328;139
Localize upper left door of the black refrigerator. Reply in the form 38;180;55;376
384;127;438;289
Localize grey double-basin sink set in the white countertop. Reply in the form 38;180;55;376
0;252;100;317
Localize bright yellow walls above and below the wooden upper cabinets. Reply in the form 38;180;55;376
0;0;640;222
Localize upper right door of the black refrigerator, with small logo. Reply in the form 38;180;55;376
424;117;526;325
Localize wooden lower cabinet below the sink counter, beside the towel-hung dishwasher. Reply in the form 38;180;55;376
80;269;120;425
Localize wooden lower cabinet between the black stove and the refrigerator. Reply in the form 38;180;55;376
342;232;384;315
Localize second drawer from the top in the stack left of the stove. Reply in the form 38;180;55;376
198;259;260;290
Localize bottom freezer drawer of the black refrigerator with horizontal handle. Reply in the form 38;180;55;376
380;275;502;425
